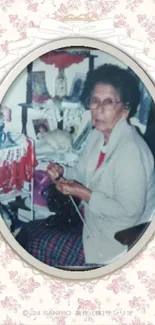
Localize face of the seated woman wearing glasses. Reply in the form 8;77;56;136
89;83;129;133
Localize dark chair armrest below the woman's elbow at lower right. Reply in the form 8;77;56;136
114;221;151;250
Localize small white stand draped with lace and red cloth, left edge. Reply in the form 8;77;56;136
0;131;36;220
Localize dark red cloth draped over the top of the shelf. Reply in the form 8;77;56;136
40;52;86;69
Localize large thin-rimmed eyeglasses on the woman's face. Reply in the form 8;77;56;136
86;96;121;112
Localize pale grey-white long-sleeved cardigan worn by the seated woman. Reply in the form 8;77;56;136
65;119;155;264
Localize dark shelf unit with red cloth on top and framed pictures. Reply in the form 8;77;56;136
19;49;97;135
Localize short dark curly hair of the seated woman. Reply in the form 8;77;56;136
80;64;140;118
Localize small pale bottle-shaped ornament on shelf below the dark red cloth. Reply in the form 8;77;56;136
55;69;67;99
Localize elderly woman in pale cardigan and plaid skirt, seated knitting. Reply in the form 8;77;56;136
15;64;155;266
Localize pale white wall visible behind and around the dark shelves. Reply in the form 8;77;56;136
2;50;126;136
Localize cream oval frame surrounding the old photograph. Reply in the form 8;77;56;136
0;37;155;281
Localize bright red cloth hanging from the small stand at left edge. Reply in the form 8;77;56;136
0;139;37;193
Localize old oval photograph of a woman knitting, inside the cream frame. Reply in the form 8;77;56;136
0;48;155;270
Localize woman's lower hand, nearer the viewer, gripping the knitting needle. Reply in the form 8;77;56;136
56;178;91;202
